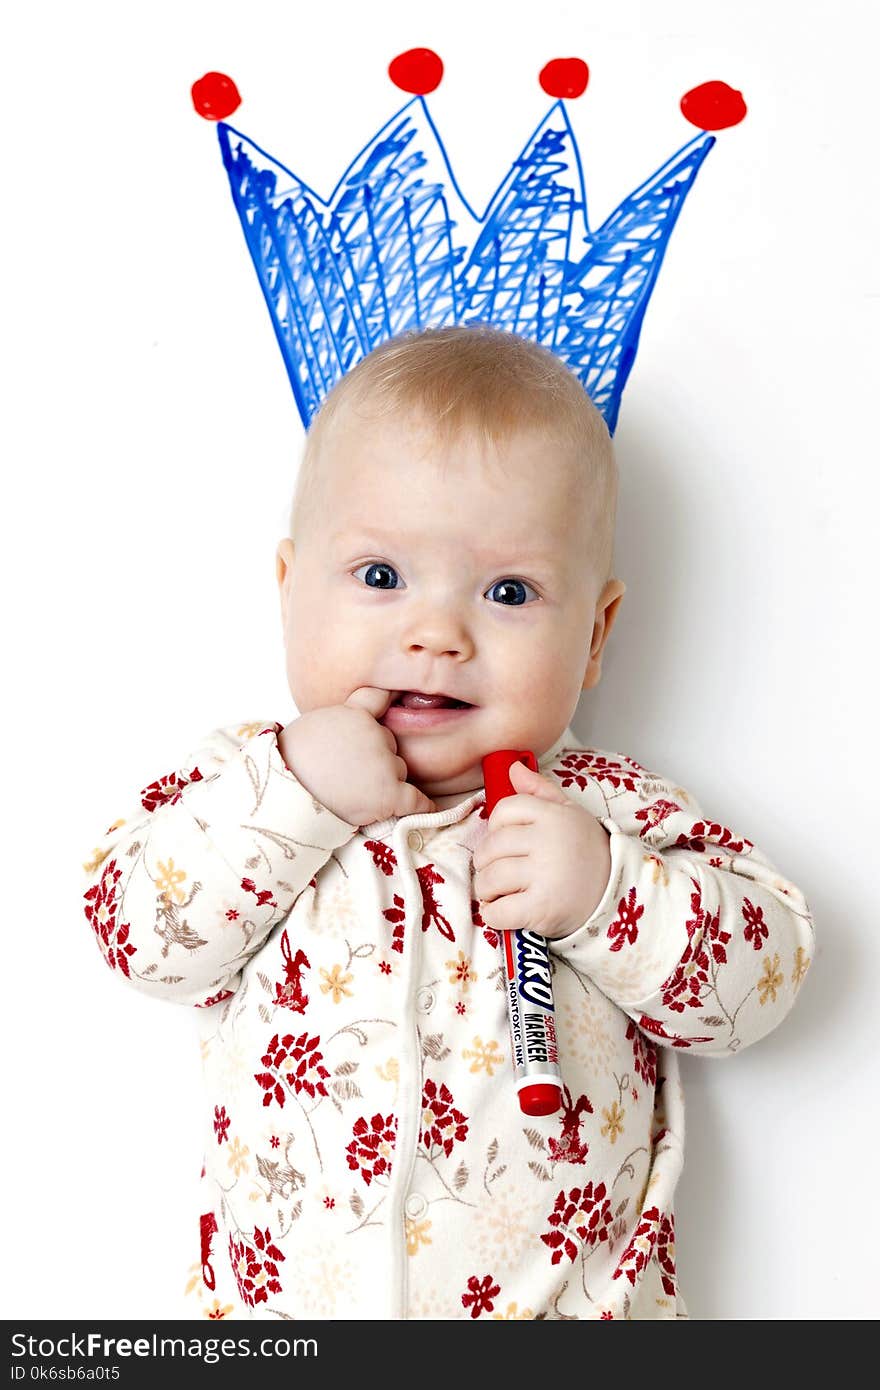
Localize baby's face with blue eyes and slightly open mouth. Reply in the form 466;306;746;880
278;405;623;799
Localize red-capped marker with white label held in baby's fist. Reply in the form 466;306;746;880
482;748;562;1115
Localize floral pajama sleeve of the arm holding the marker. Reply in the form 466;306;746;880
551;753;813;1056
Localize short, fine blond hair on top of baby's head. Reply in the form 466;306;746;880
291;324;617;581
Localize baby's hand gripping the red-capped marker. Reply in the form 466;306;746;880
474;763;612;938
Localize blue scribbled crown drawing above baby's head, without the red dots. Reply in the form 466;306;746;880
218;96;715;434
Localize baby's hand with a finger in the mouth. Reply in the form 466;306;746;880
278;685;437;826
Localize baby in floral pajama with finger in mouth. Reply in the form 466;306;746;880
85;325;812;1319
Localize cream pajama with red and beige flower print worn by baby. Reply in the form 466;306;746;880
85;723;813;1319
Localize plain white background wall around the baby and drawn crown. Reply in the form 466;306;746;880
0;0;880;1319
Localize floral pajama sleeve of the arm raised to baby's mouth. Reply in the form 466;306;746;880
83;723;356;1005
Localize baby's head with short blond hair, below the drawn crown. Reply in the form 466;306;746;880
277;325;624;801
